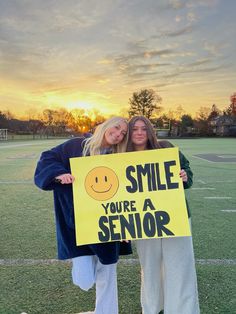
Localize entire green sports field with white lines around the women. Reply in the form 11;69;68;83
0;139;236;314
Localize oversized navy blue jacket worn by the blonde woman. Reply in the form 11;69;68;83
34;138;132;264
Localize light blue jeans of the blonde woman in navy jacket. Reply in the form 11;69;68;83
72;255;118;314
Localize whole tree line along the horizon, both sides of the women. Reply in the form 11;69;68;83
0;89;236;136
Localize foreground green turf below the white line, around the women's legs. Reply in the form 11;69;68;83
0;264;236;314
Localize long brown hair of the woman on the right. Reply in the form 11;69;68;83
126;116;161;152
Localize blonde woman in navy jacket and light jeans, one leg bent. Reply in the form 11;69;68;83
35;117;131;314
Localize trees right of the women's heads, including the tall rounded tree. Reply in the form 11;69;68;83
129;89;236;136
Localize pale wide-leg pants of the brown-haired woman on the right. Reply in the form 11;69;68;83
135;237;200;314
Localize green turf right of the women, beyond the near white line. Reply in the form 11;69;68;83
172;139;236;259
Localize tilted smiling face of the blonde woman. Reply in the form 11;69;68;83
104;121;128;146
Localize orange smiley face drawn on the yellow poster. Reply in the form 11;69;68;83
84;166;119;201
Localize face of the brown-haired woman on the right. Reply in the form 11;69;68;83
131;120;148;149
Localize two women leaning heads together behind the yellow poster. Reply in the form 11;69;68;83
35;116;199;314
